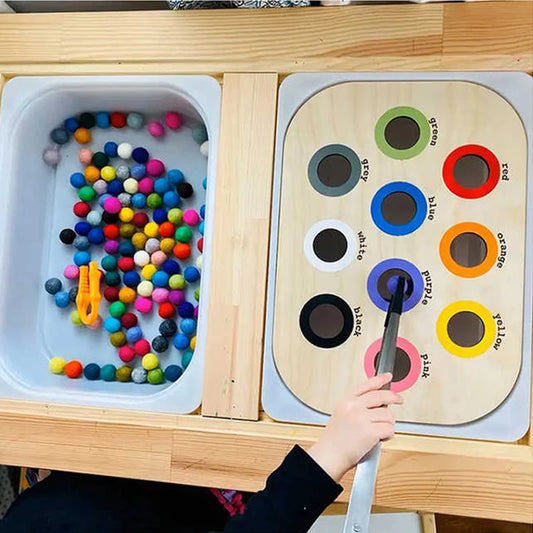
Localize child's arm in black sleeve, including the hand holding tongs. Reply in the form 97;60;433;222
224;374;403;533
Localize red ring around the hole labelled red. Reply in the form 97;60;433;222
442;144;500;198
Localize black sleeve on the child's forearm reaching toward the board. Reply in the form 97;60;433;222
224;446;342;533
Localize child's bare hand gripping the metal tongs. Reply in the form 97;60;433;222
308;373;403;482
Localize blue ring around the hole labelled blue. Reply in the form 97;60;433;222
370;181;428;235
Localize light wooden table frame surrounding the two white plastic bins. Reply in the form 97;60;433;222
0;1;533;523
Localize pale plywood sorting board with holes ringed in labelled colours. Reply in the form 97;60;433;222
273;81;526;424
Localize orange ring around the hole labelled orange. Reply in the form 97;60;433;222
439;222;498;278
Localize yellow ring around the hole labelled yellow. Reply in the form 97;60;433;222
437;300;496;357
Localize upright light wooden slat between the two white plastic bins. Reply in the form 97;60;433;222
202;74;278;420
